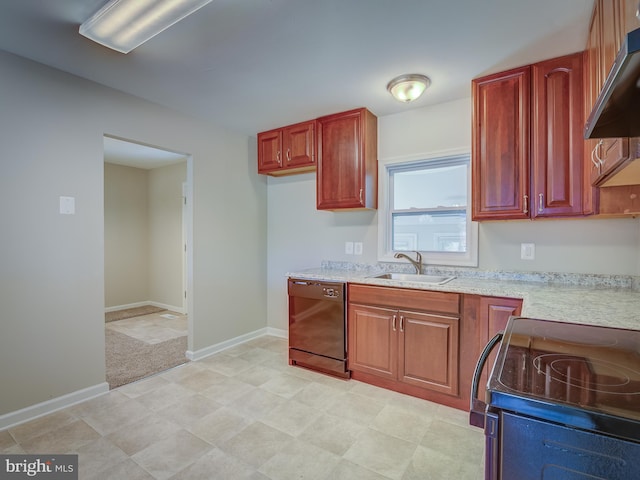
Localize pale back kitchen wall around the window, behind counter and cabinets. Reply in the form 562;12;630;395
268;99;640;329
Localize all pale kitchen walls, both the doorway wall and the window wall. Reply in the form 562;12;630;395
0;44;640;420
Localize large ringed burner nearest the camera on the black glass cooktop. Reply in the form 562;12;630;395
533;353;640;395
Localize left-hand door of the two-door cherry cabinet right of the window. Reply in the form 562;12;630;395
472;66;531;220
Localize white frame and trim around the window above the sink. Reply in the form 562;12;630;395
378;149;478;267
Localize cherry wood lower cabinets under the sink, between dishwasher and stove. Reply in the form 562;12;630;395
347;284;522;410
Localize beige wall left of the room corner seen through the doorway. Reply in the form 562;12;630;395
104;163;150;308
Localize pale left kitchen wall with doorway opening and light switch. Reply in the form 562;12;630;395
0;52;267;417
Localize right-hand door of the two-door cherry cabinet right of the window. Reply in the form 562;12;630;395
531;52;584;218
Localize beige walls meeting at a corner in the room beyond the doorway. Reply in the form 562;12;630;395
104;160;187;313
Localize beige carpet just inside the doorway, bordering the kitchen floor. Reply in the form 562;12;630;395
105;328;188;388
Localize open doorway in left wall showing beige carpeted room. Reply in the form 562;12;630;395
104;136;191;388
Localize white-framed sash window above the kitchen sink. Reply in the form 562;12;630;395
378;153;478;266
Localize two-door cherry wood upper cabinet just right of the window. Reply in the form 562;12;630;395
472;52;584;220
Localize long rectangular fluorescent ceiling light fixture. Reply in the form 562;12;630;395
80;0;211;53
